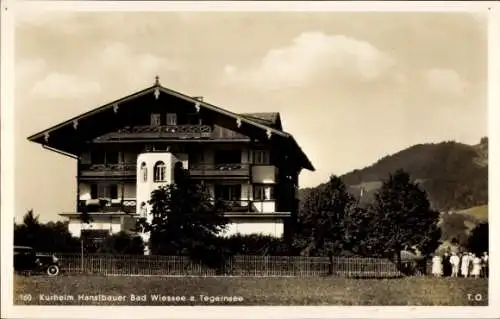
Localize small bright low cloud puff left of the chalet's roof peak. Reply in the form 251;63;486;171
31;72;101;98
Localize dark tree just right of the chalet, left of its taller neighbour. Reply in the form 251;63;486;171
293;175;356;256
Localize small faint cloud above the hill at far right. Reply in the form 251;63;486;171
425;68;468;96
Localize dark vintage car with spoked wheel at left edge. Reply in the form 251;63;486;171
14;246;60;277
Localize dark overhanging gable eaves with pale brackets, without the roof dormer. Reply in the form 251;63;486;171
28;83;314;171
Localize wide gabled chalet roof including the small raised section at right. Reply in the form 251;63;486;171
28;78;314;170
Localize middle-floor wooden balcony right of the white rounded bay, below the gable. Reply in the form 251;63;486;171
189;163;250;178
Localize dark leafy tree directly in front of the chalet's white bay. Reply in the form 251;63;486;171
140;169;227;259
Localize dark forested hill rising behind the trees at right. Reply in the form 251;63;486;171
301;137;488;211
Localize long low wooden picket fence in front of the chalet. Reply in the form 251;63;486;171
52;254;429;278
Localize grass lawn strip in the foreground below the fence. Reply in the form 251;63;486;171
14;276;488;306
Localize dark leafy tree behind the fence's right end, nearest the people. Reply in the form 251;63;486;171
363;170;441;269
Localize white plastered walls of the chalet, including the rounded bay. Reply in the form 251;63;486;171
68;145;290;254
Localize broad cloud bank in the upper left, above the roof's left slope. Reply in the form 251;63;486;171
23;42;177;98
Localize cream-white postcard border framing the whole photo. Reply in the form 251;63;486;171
0;1;500;318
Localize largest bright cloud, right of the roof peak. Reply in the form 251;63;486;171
224;32;395;87
